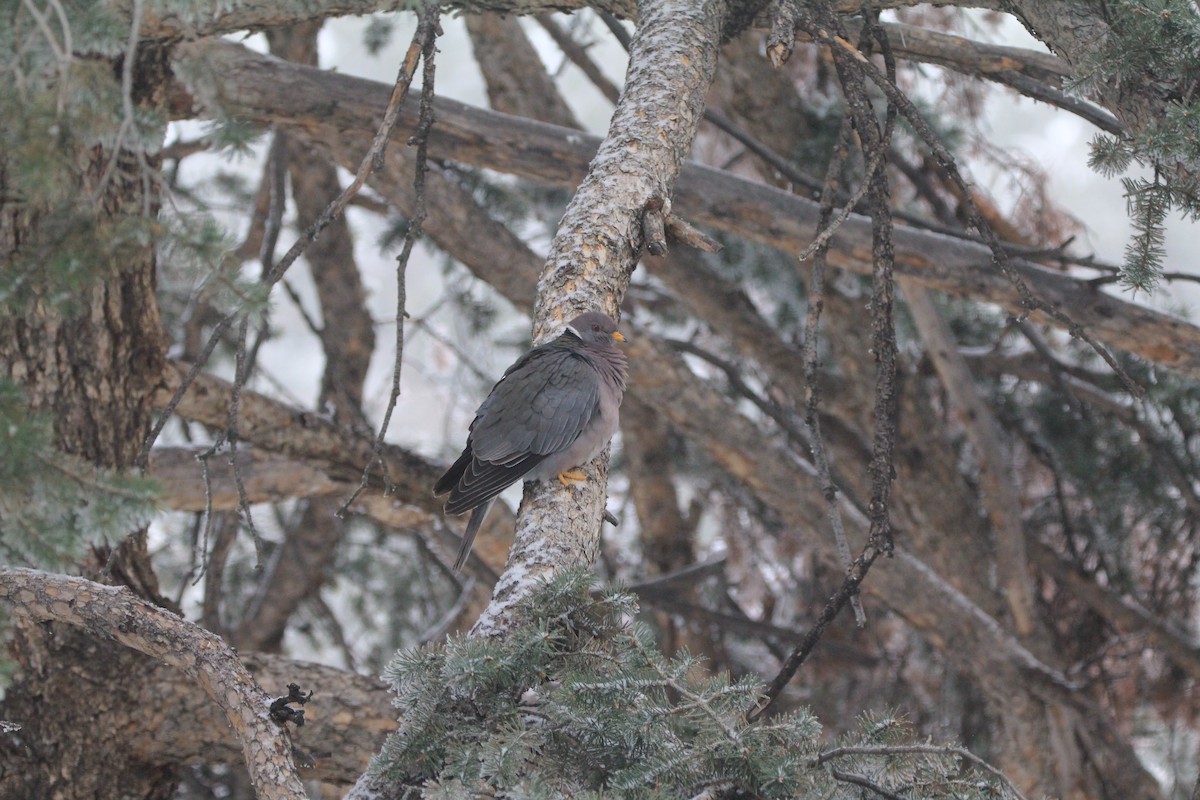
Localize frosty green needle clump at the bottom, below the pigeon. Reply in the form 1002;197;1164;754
372;572;1010;799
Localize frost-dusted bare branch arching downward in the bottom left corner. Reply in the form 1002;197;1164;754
0;567;307;800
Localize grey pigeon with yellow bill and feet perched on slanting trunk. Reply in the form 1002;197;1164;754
433;311;628;572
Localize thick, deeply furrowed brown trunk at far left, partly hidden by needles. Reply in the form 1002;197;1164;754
0;47;178;800
